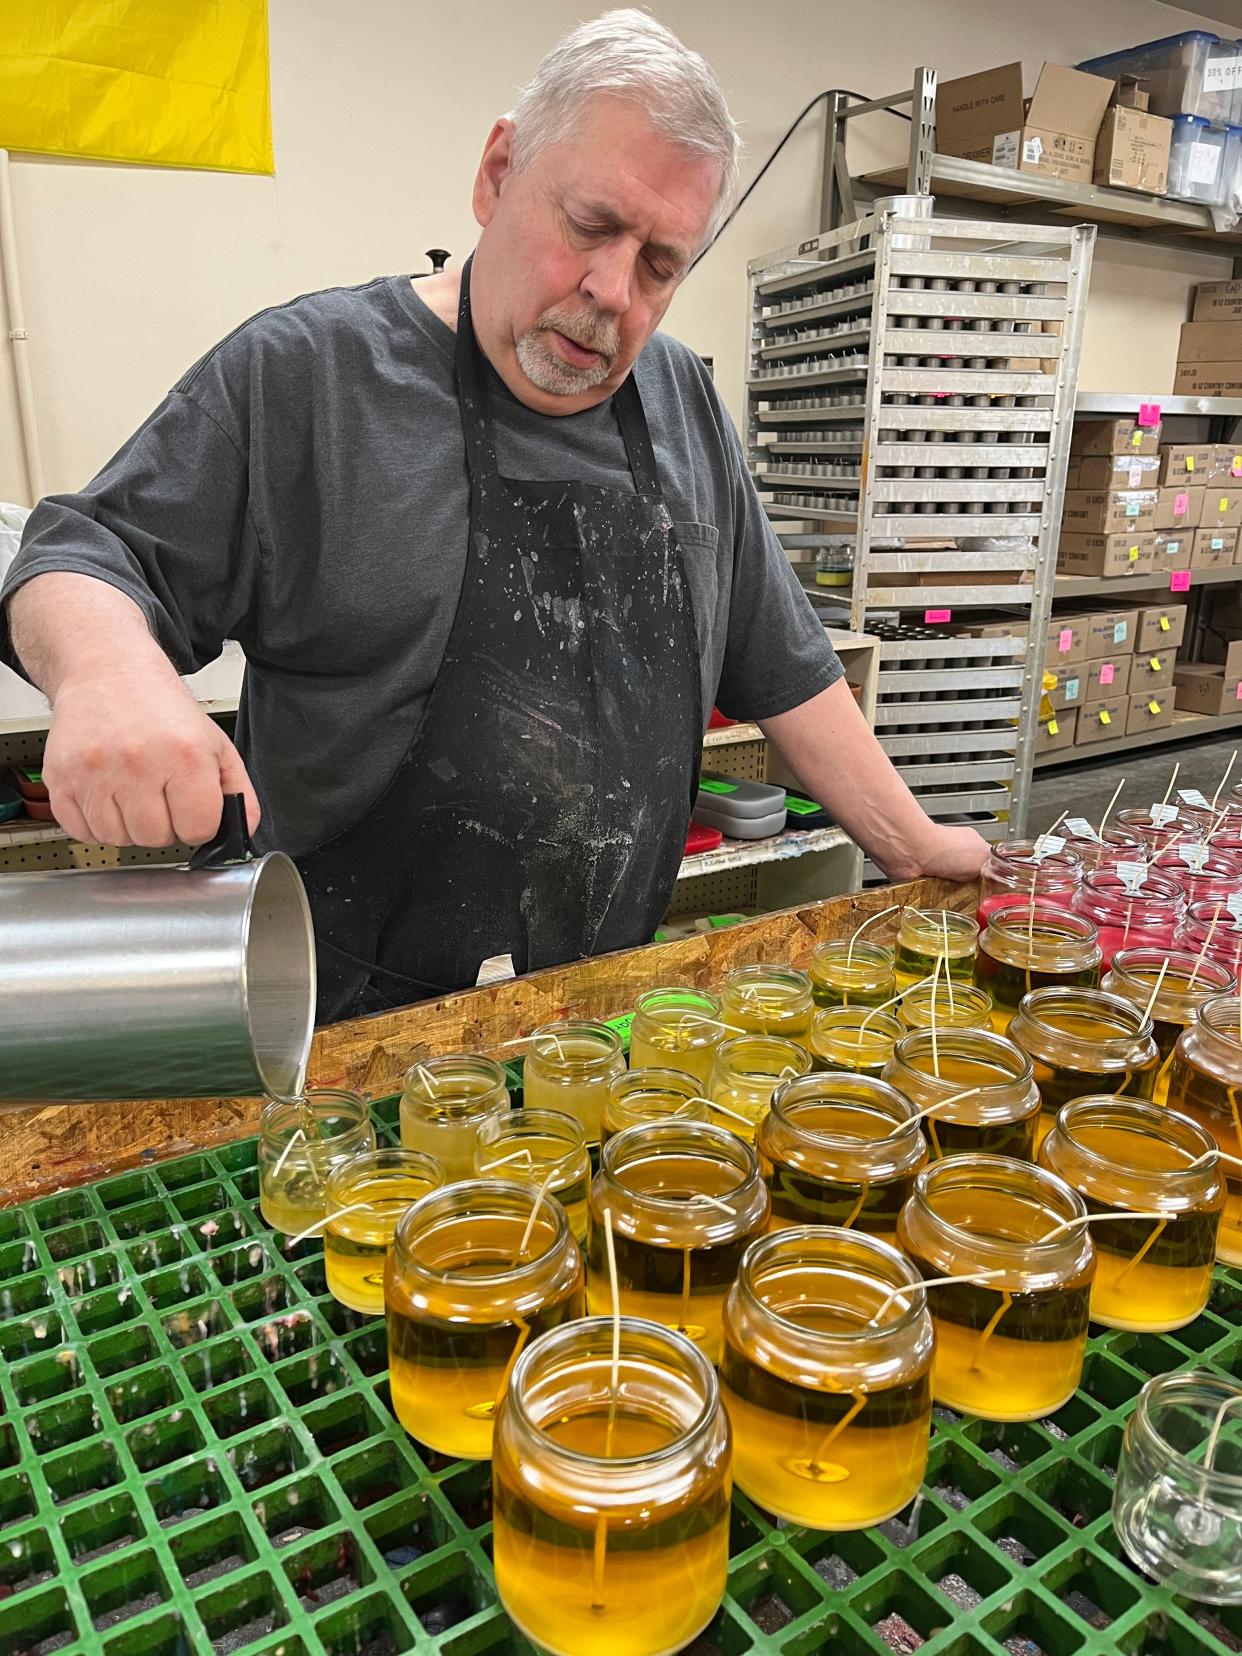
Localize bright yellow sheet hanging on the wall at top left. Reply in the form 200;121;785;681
0;0;275;172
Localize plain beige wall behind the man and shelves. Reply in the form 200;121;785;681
0;0;1229;500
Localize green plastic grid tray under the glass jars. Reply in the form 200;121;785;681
0;1100;1242;1656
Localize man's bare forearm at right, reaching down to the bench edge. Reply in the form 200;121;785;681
760;679;936;879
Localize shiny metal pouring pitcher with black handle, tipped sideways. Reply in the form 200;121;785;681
0;793;315;1105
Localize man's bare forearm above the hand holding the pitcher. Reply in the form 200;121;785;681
8;571;177;702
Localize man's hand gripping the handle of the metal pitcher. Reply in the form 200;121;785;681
43;662;258;848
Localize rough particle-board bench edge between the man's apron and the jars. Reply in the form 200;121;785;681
0;879;977;1206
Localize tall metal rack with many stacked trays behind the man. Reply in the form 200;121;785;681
747;200;1095;838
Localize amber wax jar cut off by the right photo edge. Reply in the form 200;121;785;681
1169;994;1242;1265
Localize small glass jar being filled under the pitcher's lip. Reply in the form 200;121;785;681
258;1086;376;1237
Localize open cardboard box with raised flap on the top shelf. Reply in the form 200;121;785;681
936;63;1113;184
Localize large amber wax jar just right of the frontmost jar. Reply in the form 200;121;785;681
720;1225;934;1530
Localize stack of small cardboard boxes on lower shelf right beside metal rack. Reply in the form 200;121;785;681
1035;604;1186;753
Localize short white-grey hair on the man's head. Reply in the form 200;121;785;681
510;8;742;247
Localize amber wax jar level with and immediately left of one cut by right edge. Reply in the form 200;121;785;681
1009;989;1159;1149
